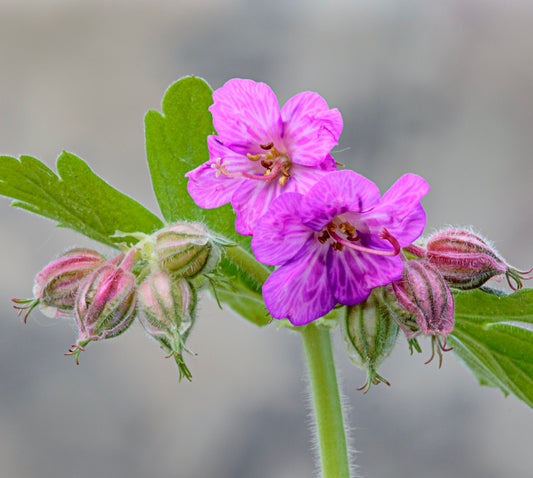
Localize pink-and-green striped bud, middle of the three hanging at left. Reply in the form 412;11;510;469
66;249;137;362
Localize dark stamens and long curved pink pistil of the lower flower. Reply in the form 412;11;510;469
318;216;401;256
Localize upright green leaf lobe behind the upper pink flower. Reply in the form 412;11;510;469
145;76;245;247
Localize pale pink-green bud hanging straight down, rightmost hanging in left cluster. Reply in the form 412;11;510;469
138;269;197;380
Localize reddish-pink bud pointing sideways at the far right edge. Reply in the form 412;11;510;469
426;229;531;290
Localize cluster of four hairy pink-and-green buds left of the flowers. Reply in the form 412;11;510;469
13;223;225;380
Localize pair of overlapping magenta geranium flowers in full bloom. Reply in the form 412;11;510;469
186;79;429;326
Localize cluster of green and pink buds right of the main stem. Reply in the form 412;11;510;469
342;229;533;384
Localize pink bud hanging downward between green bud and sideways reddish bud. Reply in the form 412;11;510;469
392;260;454;363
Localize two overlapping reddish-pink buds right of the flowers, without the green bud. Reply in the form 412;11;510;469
386;229;533;366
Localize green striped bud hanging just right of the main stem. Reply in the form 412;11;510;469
342;288;398;393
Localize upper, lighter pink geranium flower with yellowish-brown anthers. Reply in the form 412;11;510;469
186;79;342;235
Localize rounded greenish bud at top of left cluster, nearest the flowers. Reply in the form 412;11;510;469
154;222;220;277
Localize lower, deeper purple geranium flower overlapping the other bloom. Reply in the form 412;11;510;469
252;170;429;325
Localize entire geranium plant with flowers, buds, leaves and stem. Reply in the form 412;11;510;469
0;77;533;478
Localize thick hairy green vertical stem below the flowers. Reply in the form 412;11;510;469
301;323;350;478
